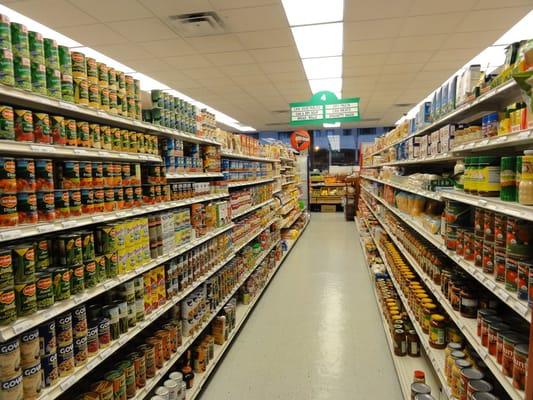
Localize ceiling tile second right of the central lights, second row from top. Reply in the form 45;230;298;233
399;13;466;36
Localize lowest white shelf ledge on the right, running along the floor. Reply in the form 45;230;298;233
355;222;438;399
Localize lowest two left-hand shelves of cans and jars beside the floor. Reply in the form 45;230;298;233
59;219;308;400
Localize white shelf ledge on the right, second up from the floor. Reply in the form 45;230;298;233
372;225;454;399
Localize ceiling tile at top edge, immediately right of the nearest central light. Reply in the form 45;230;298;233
344;0;412;21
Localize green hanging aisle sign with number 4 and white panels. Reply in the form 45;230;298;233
289;91;361;125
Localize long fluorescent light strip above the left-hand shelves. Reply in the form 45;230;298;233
0;4;255;132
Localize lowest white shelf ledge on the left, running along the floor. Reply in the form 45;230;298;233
186;219;307;400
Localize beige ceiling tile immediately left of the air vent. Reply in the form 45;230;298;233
112;18;177;42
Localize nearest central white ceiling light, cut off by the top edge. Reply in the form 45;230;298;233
282;0;344;26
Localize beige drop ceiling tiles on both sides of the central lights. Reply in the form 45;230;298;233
5;0;533;129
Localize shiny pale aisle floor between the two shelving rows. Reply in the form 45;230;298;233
201;213;402;400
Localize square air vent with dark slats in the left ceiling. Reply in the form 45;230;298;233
168;11;226;37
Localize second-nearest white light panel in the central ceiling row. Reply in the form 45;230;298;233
291;22;343;58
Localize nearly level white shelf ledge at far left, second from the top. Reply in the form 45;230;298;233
0;140;163;163
